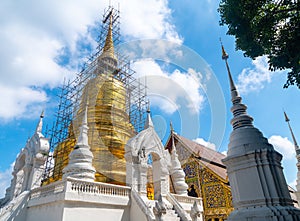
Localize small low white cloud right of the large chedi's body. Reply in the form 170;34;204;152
268;135;295;159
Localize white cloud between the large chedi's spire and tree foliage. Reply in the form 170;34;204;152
237;56;279;94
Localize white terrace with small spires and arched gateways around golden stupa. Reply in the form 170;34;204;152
0;107;203;221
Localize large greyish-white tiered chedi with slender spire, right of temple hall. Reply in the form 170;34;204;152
222;46;300;221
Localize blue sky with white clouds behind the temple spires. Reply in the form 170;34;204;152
0;0;300;196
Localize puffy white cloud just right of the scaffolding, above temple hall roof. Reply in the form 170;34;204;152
131;59;205;114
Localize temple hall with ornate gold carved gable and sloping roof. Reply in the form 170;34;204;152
165;127;233;221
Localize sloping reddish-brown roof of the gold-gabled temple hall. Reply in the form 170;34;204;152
165;133;227;180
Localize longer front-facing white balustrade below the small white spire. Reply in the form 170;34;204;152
67;178;130;197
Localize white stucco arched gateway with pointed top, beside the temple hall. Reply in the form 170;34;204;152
125;109;187;199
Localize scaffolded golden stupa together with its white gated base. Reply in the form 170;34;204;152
0;7;203;221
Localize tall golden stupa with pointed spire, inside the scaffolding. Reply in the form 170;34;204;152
46;16;135;185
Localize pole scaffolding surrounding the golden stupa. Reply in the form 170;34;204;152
42;6;147;185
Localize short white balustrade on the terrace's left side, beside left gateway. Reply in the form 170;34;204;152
30;181;66;199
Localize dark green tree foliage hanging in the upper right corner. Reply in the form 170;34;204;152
218;0;300;88
